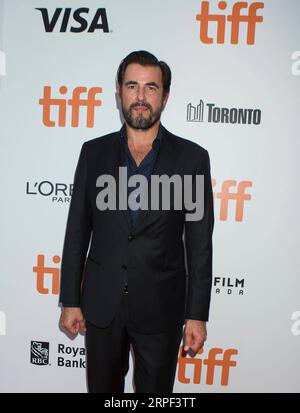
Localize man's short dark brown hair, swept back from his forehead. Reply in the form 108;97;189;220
117;50;172;95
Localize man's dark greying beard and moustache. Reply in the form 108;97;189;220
122;102;163;130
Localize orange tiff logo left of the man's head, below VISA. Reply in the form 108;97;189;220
39;86;102;128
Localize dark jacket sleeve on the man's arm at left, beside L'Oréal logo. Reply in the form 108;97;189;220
60;144;92;307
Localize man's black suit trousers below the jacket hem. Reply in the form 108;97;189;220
86;292;183;393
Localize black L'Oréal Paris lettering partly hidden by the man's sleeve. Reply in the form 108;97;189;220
26;181;73;203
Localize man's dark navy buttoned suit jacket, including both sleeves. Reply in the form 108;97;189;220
60;124;214;334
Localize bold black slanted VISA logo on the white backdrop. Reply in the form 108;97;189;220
36;7;109;33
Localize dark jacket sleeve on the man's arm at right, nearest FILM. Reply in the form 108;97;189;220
185;151;214;321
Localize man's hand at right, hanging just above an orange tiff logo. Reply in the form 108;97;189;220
183;320;207;355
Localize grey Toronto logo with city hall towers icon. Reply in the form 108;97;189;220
186;99;261;125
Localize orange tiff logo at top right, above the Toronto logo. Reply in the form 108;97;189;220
196;1;264;45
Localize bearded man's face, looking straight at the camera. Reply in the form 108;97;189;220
117;63;169;130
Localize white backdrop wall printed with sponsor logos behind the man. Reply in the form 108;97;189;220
0;0;300;393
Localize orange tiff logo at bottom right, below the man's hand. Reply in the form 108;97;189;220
178;346;238;386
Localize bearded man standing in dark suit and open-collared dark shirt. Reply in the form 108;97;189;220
60;51;214;392
